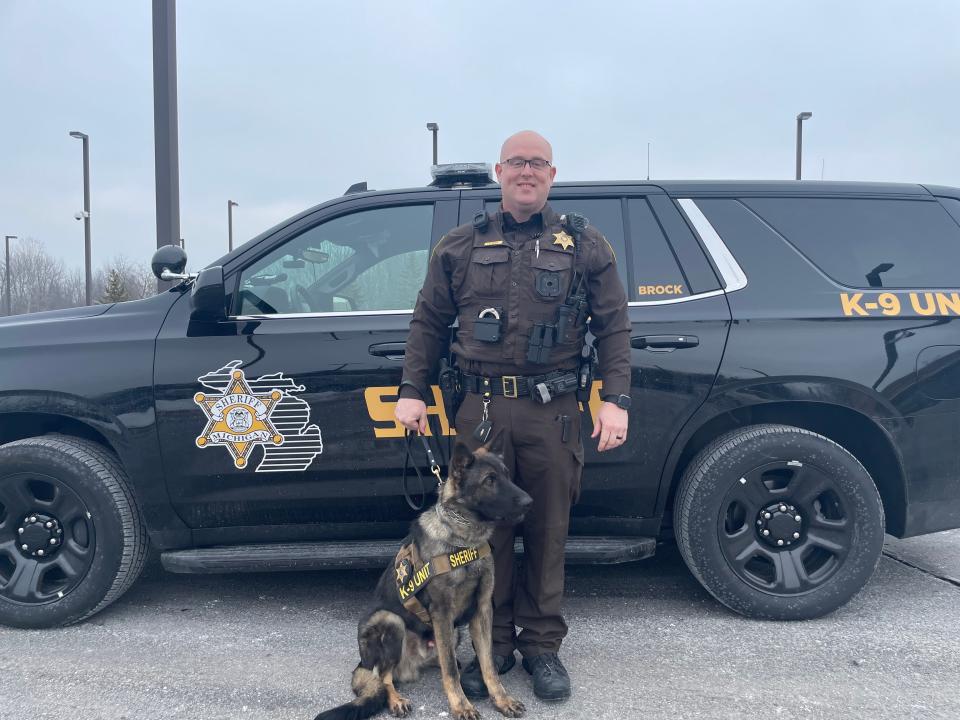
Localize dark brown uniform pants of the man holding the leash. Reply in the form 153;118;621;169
456;393;583;657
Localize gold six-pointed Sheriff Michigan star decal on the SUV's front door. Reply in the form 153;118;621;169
193;370;283;468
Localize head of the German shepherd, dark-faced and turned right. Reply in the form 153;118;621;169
443;434;533;523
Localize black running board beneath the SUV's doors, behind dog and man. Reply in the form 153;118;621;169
160;535;657;573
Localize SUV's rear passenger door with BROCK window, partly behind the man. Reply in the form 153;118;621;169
460;186;730;518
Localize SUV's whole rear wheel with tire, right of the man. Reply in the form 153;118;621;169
674;424;884;620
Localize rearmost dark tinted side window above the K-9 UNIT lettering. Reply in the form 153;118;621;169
741;198;960;288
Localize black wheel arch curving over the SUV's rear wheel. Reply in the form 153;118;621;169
657;390;907;536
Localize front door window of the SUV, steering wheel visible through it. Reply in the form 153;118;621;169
239;204;433;315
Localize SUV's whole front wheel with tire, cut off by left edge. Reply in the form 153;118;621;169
0;435;148;628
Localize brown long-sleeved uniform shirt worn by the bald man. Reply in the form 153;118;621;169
400;205;630;398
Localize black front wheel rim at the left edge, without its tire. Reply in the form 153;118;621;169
0;473;96;605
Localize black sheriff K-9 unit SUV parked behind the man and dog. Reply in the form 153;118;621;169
0;166;960;627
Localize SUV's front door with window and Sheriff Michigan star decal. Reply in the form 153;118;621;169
155;191;457;541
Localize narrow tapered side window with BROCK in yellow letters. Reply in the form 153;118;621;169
627;198;696;302
